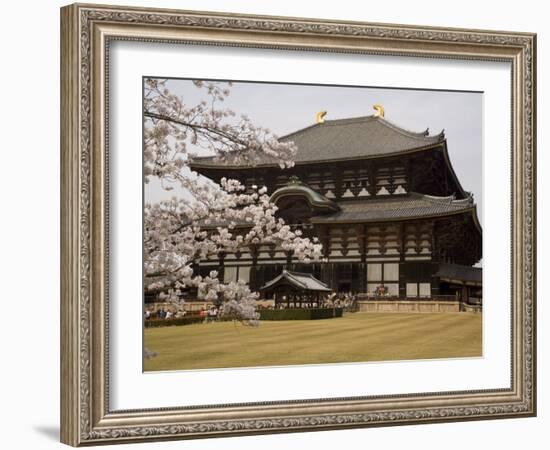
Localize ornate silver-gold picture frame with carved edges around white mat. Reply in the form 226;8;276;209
61;4;536;446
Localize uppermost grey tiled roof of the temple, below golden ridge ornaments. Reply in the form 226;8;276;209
192;116;445;167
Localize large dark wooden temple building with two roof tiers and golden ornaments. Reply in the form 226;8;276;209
192;107;482;310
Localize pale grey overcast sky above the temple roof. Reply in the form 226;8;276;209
145;80;483;222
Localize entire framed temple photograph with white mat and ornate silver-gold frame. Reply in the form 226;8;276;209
61;5;536;446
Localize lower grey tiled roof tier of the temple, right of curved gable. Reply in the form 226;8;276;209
311;192;474;223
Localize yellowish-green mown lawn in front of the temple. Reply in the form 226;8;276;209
145;313;482;371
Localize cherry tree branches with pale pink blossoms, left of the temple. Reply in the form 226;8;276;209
143;79;321;324
